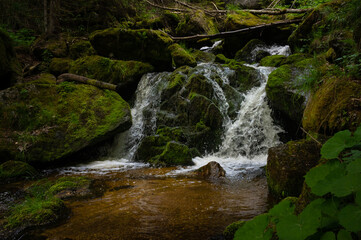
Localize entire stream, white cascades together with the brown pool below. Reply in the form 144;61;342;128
24;46;289;240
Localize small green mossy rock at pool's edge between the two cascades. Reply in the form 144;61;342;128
149;141;194;166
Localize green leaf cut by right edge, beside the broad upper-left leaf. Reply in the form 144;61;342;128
330;173;361;197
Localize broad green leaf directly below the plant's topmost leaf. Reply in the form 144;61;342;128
305;160;346;196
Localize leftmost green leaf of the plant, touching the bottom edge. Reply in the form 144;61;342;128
234;214;272;240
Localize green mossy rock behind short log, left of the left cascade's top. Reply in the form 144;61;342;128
69;55;154;100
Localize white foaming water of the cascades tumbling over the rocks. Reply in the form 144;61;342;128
63;46;290;177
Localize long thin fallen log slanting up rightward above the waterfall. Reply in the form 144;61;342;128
168;19;302;41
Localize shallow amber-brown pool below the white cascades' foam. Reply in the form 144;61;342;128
29;168;268;240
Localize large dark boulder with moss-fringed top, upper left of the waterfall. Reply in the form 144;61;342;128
89;28;173;71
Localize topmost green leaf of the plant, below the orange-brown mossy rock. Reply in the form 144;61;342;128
321;130;354;159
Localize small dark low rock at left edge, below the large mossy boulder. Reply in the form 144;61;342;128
0;161;39;181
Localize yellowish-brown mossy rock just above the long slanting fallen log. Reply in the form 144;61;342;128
175;10;218;36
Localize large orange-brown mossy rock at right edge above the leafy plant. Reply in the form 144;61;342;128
302;76;361;136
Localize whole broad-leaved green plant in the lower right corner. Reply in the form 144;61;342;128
235;126;361;240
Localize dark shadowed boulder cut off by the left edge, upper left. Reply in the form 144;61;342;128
0;29;21;90
